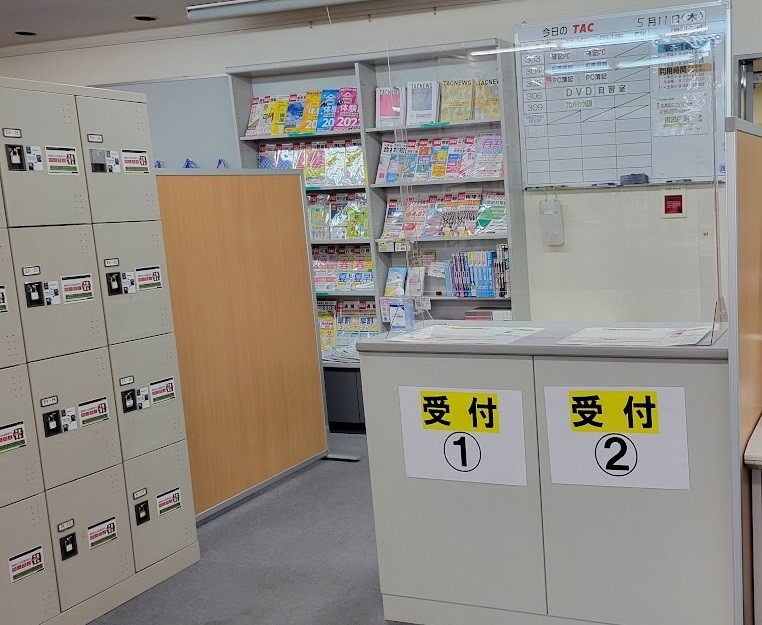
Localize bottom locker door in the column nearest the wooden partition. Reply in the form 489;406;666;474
124;441;197;571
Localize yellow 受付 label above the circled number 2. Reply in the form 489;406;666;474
569;389;659;434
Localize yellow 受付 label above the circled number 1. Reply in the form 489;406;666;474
420;390;500;434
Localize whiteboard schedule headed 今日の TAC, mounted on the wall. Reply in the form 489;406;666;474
515;2;728;188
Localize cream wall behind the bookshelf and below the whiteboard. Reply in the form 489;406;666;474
0;0;744;320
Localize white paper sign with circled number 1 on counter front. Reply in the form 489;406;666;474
399;386;527;486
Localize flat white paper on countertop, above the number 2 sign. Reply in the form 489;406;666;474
557;326;712;347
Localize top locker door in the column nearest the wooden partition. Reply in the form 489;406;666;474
77;97;159;223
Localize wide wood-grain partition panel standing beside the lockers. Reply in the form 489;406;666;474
158;173;327;513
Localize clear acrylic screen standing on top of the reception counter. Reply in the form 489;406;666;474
366;25;725;342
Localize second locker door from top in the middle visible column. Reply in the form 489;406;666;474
10;226;106;361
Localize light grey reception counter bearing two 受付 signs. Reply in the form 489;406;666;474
358;324;742;625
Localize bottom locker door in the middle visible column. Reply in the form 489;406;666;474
47;465;135;610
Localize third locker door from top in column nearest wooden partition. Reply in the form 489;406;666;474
109;334;185;460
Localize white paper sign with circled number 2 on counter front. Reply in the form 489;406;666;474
545;385;690;490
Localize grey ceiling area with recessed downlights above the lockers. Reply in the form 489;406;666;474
0;0;199;47
